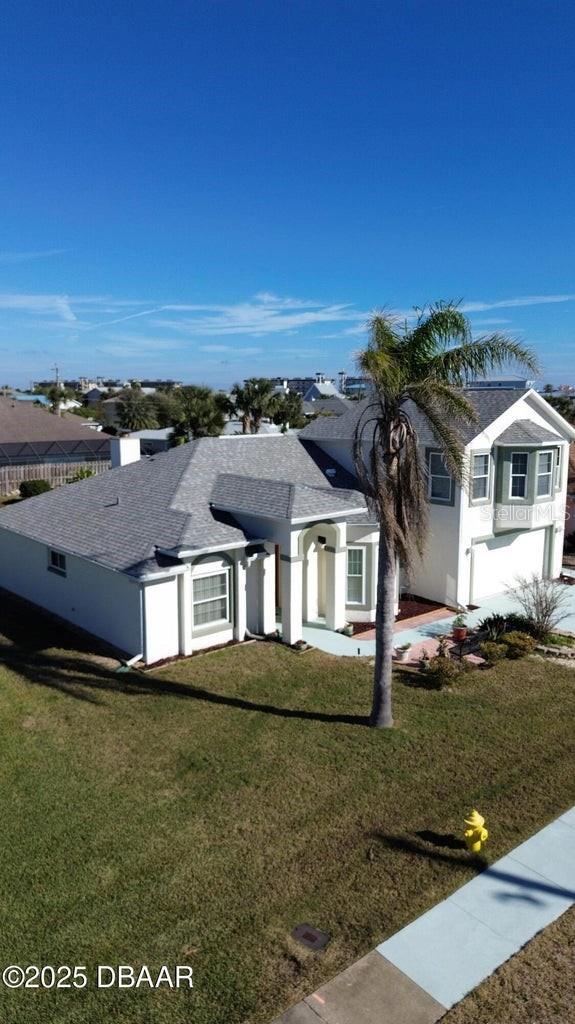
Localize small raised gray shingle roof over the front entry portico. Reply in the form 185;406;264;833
211;473;365;519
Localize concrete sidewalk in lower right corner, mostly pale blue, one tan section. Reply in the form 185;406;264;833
275;807;575;1024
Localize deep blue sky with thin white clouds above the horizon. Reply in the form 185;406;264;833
0;0;575;385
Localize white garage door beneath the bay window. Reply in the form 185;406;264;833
471;529;546;604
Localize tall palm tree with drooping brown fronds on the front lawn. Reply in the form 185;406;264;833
354;302;538;728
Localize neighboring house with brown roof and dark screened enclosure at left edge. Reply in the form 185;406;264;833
0;398;109;494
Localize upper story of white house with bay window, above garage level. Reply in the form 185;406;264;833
302;388;575;539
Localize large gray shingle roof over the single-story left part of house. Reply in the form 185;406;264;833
0;435;355;575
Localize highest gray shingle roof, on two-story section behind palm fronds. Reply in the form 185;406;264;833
300;388;525;444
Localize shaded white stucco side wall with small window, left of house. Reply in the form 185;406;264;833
0;528;141;655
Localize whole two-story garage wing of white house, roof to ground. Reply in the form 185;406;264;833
300;388;575;606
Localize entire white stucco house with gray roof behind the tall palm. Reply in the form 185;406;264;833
0;390;575;664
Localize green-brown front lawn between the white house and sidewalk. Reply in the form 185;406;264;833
0;601;575;1024
